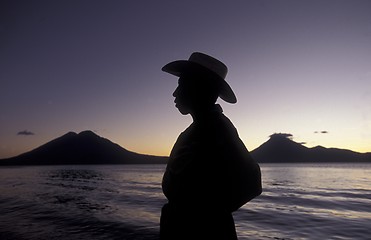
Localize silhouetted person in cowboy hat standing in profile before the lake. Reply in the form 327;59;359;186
160;53;262;240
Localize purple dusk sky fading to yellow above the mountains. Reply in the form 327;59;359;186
0;0;371;158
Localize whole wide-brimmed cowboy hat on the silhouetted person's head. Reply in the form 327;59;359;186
162;52;237;103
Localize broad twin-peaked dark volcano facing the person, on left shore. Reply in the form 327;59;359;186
0;131;167;165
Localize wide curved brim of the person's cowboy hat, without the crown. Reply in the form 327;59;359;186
162;60;237;103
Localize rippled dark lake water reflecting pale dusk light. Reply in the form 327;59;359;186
0;164;371;240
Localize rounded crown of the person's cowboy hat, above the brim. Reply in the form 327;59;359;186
188;52;228;79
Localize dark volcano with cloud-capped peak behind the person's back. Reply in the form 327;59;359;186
251;134;371;163
